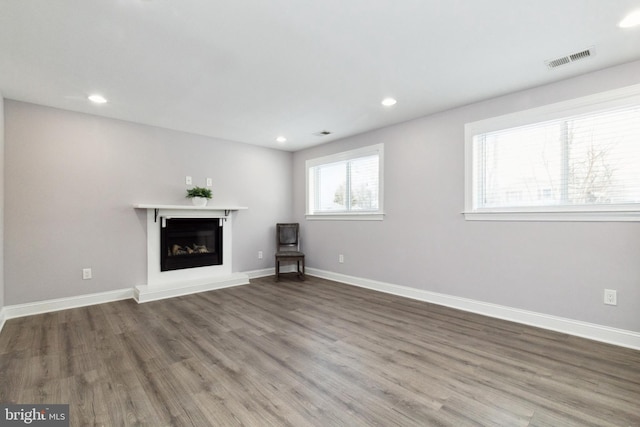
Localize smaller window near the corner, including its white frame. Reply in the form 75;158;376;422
306;144;384;220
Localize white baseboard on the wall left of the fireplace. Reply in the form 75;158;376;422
0;289;133;319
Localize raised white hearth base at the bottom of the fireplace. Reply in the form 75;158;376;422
133;273;249;303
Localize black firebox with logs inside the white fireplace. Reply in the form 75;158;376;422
160;218;222;271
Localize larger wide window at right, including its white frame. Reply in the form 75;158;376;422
465;85;640;221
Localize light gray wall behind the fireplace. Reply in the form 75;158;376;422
4;100;292;305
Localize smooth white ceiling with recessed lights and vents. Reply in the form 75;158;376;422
0;0;640;151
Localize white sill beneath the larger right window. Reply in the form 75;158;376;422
462;210;640;222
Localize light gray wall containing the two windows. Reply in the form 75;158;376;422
293;62;640;331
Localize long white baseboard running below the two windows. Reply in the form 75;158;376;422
307;268;640;350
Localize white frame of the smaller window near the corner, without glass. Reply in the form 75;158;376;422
305;143;384;221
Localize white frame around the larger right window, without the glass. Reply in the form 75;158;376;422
462;84;640;221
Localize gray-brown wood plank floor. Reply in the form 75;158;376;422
0;277;640;427
